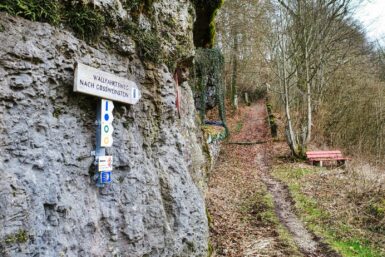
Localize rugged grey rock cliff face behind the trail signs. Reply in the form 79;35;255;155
0;0;213;257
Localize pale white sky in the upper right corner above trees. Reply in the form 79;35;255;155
355;0;385;44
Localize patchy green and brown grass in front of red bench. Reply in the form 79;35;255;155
274;159;385;257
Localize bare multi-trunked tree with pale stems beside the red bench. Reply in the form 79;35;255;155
273;0;350;157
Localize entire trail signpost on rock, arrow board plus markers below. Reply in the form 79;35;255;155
74;63;141;187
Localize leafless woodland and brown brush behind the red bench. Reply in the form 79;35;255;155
217;0;385;164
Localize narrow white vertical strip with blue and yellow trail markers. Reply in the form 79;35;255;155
100;99;114;147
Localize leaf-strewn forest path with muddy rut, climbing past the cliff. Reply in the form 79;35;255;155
207;101;339;257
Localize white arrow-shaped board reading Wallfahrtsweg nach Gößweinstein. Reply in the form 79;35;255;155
74;63;141;104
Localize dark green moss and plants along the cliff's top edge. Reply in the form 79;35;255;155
0;0;185;67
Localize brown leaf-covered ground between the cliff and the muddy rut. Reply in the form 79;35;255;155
206;100;301;257
